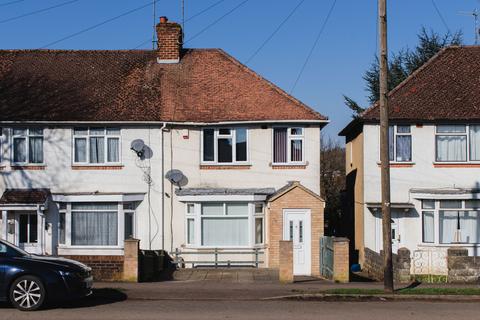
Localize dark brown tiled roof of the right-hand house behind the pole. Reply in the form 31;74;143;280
361;46;480;121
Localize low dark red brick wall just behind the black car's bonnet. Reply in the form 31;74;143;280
63;256;124;281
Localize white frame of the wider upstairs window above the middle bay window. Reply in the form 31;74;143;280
200;127;250;166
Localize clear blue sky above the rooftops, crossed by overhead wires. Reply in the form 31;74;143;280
0;0;480;141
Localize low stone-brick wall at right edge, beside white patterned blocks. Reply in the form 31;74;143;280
447;248;480;283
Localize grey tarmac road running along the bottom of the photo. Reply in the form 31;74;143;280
0;300;480;320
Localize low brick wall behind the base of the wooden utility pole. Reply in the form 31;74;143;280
362;248;411;282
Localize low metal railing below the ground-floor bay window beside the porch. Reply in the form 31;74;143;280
171;248;264;268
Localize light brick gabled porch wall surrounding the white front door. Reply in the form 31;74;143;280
267;187;324;276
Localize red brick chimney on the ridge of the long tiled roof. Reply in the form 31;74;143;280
157;17;183;63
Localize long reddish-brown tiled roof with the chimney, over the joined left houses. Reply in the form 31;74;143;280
0;49;326;123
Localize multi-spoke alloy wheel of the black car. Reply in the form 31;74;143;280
10;276;46;311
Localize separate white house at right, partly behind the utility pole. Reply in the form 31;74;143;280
340;46;480;275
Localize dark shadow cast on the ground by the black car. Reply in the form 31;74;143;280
0;288;127;310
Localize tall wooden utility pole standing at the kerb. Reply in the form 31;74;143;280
378;0;393;293
